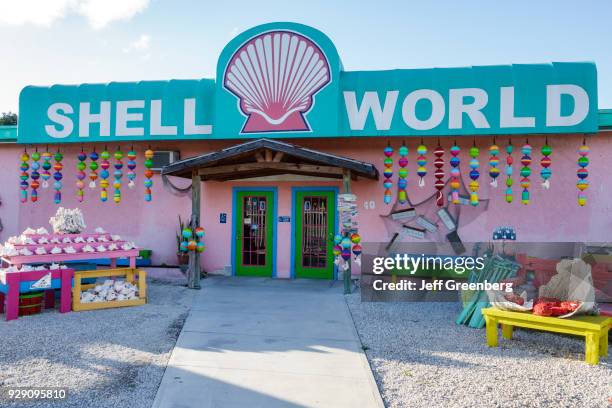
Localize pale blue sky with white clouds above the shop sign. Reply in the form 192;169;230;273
0;0;612;112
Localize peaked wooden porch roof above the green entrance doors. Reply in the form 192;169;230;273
162;139;378;181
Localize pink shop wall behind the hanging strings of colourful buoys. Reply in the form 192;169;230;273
0;133;612;277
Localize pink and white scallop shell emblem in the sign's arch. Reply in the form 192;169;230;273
223;30;330;133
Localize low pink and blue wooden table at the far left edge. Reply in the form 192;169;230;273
0;269;74;321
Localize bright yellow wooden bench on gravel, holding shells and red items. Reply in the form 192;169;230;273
482;307;612;364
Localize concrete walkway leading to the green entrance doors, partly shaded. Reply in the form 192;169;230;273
153;277;383;408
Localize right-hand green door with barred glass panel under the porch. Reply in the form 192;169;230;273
293;191;336;279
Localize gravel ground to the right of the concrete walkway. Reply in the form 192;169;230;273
347;293;612;408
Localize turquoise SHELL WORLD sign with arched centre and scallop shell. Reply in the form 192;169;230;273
18;23;597;144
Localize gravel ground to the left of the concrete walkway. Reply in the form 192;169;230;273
0;275;194;408
